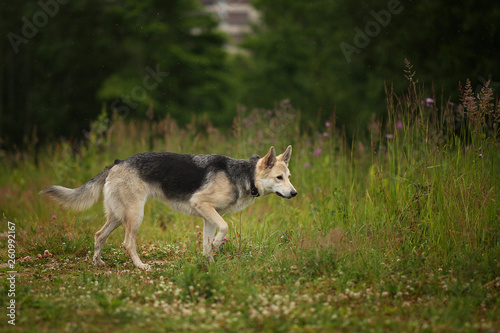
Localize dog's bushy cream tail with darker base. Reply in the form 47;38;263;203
40;162;116;210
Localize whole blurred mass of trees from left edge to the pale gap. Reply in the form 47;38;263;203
0;0;228;148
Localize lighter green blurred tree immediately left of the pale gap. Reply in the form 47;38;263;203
99;0;228;122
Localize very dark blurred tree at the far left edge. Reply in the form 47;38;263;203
0;0;124;147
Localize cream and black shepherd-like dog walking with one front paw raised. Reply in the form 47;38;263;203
40;146;297;270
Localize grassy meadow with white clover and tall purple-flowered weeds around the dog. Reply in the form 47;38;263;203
0;83;500;332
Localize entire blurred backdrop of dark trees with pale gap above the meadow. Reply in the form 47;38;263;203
0;0;500;150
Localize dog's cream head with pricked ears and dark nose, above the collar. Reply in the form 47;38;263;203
255;146;297;199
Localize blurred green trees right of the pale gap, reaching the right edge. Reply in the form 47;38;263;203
238;0;500;132
